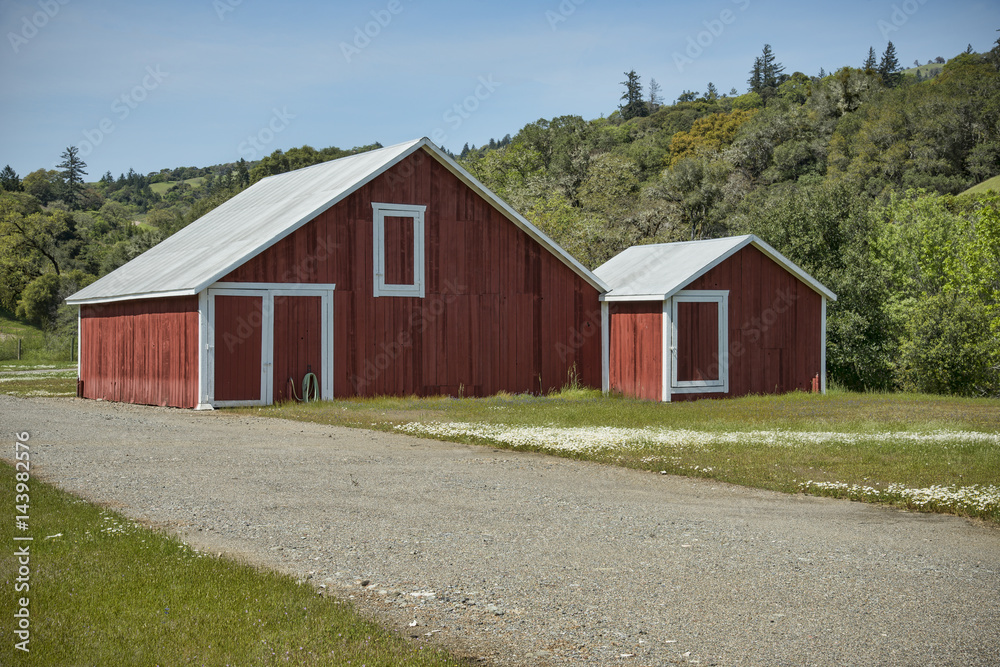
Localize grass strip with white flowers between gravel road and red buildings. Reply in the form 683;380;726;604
238;391;1000;522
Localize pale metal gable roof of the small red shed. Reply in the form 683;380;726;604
594;234;837;301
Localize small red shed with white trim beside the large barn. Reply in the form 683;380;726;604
594;235;837;401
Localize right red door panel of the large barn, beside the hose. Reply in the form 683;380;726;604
274;296;329;403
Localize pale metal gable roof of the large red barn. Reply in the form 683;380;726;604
66;137;607;304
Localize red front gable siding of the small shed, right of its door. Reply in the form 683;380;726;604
672;246;823;400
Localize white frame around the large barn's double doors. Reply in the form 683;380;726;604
195;282;336;410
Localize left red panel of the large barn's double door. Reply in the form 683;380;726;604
215;295;264;401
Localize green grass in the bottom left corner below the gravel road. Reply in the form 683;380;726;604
0;464;464;667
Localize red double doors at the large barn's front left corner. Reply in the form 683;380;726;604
208;288;333;407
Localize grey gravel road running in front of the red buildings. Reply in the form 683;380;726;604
0;396;1000;665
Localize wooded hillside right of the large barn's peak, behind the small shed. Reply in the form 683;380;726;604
464;42;1000;396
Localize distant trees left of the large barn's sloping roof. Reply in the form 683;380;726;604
0;144;380;344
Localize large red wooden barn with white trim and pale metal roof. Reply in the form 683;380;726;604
67;138;607;409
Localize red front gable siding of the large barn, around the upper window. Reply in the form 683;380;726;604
222;151;601;397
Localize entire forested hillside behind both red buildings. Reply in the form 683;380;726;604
0;40;1000;395
